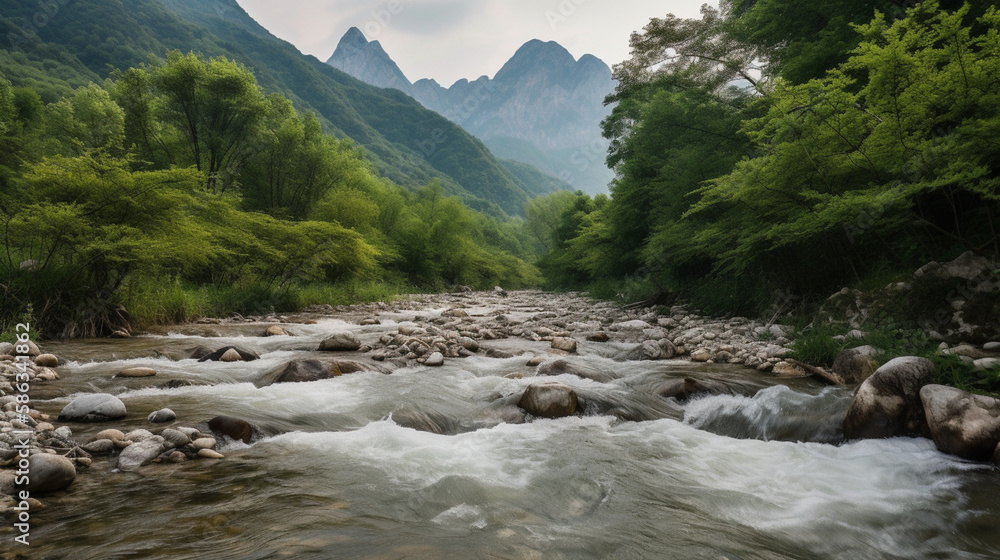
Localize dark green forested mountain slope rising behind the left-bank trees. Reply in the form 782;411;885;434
0;0;550;214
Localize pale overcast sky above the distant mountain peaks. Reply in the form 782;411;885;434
237;0;718;86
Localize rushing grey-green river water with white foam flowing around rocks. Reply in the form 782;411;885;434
13;320;1000;560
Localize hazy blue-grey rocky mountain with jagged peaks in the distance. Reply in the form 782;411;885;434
327;28;615;193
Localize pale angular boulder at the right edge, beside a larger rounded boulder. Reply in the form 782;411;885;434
920;385;1000;461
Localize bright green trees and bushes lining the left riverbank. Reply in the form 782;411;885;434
0;51;537;336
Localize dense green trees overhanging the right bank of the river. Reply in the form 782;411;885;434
529;0;1000;320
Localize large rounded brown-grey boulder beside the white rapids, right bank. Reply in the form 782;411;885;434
844;356;934;439
